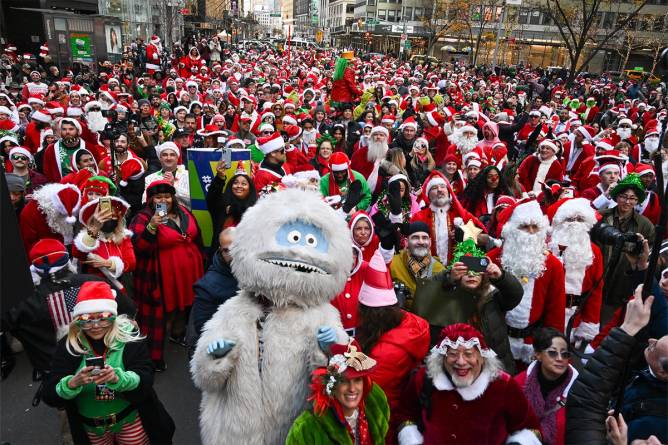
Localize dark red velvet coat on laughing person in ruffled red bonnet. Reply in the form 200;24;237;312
396;367;540;445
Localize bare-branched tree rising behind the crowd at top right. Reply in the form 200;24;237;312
543;0;648;84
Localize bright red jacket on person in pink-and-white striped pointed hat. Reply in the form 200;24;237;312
369;311;429;444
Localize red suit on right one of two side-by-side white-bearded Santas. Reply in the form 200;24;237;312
553;243;603;342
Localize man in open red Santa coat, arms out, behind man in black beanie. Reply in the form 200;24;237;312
411;170;484;263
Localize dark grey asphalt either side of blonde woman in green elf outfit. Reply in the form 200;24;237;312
0;343;200;445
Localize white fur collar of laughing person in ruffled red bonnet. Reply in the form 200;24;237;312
427;351;501;401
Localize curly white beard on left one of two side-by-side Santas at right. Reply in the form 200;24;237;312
501;227;547;278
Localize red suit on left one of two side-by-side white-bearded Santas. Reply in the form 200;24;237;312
487;248;566;363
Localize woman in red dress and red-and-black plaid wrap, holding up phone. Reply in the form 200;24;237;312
130;180;204;371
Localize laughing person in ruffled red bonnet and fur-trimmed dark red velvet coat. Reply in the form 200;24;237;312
397;323;542;445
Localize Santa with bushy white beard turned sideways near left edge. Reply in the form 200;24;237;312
20;184;81;252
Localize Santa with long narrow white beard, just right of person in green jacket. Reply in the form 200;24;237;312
350;125;390;193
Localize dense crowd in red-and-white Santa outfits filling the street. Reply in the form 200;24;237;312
0;36;668;445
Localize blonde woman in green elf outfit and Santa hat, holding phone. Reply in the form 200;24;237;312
42;281;175;445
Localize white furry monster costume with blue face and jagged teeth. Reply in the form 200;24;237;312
190;189;352;445
